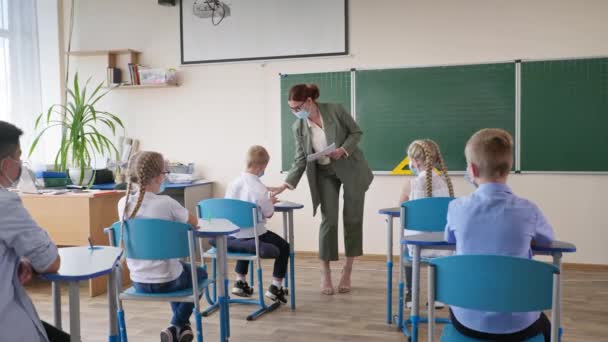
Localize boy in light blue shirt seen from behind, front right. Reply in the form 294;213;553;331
445;129;553;341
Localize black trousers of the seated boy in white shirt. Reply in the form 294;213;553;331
209;230;289;279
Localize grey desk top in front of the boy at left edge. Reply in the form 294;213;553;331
42;246;122;281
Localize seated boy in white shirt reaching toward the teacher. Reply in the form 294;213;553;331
225;145;289;303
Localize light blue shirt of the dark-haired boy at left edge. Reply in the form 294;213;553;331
0;188;58;342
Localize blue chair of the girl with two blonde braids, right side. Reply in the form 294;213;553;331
396;197;454;341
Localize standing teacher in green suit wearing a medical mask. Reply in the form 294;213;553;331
270;84;373;295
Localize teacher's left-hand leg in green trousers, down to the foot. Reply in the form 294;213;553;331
318;166;341;295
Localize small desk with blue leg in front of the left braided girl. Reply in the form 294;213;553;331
194;219;240;342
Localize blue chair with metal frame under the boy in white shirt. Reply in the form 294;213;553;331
196;198;280;321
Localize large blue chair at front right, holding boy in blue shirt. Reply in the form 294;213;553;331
429;255;560;342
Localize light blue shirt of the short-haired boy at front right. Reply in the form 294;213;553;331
445;183;553;334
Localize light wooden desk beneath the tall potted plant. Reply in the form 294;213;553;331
20;190;129;297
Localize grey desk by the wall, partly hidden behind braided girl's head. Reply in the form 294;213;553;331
91;180;213;213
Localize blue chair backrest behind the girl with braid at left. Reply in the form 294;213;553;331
109;218;192;260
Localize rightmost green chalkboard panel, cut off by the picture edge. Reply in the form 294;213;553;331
521;58;608;172
